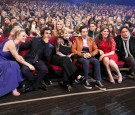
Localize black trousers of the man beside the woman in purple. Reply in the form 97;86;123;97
21;59;47;89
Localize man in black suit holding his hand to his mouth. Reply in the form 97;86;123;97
20;28;52;92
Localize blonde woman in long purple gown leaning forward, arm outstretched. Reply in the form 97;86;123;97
0;28;35;97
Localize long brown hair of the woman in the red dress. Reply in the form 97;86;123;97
96;26;111;47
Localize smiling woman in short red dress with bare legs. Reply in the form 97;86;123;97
96;26;122;84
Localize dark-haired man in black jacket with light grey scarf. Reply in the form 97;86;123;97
115;26;135;77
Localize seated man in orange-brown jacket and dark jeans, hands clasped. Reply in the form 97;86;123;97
72;26;103;88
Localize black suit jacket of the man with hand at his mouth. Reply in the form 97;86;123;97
19;37;52;62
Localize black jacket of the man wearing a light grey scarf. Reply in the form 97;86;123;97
114;35;135;61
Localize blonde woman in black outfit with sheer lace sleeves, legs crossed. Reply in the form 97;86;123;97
51;29;82;91
